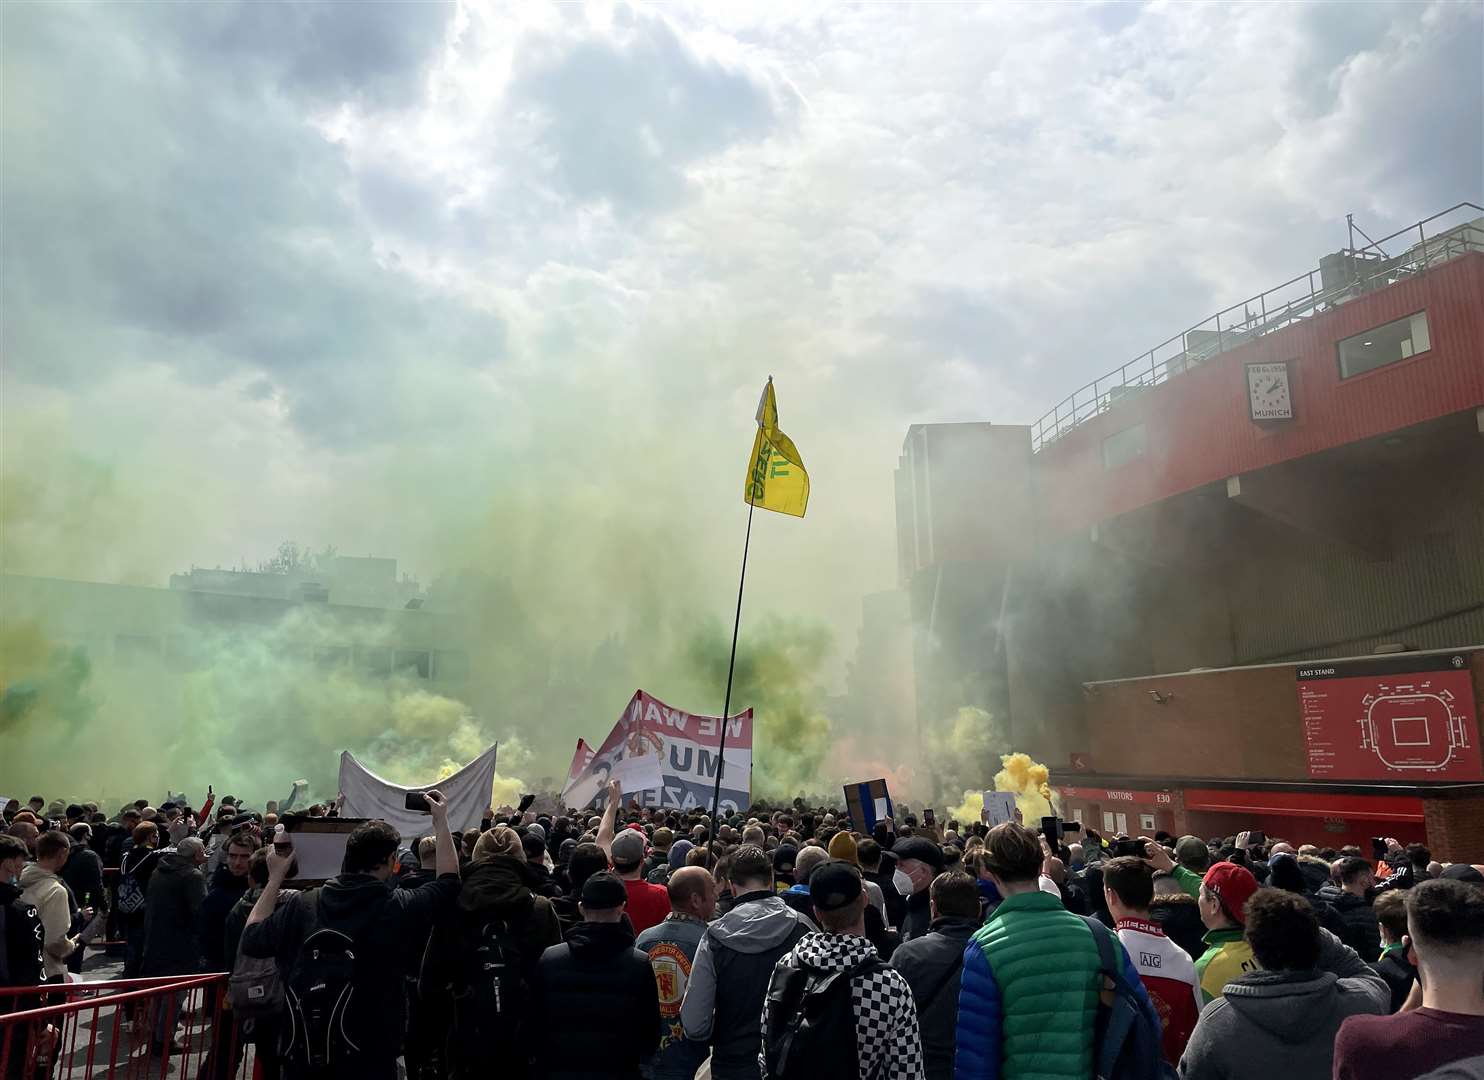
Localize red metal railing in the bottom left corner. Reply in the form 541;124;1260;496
0;973;252;1080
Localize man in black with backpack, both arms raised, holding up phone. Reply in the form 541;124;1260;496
240;791;459;1080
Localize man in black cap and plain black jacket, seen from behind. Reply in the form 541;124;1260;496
533;872;655;1080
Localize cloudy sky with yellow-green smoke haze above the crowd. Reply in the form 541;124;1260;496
0;0;1484;658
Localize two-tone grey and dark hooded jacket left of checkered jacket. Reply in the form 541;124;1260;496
680;892;815;1080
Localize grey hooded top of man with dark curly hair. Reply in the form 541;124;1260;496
1180;930;1391;1080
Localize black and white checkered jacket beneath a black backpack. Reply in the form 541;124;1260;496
758;933;923;1080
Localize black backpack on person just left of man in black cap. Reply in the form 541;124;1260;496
448;918;533;1070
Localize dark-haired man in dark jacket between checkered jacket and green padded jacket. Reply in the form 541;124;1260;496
892;871;979;1080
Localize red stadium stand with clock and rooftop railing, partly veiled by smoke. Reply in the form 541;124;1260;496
896;205;1484;859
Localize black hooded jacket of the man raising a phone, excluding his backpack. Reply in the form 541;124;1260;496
240;874;459;1058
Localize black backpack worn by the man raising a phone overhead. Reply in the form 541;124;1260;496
282;890;361;1076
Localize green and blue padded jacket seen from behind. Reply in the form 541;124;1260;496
954;892;1149;1080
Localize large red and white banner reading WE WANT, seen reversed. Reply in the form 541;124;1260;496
562;690;752;813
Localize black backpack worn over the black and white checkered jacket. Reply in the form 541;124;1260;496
763;955;883;1080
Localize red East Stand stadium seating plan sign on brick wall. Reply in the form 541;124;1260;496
1297;653;1484;780
